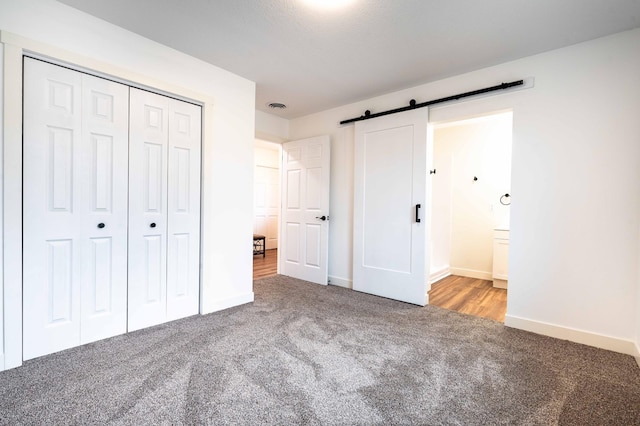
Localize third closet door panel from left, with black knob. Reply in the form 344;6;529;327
128;88;169;331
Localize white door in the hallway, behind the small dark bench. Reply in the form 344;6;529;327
253;166;280;250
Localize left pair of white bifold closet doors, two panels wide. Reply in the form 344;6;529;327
23;58;129;359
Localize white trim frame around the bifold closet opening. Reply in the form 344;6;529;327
0;31;214;371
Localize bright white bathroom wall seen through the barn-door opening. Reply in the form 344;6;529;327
430;113;512;280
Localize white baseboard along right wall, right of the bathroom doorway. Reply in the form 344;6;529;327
504;314;640;359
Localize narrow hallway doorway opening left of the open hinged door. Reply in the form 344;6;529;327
253;139;282;280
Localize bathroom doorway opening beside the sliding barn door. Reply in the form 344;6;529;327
429;112;513;322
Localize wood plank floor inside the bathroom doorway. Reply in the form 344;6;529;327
429;275;507;322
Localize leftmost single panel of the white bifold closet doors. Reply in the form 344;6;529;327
23;58;83;360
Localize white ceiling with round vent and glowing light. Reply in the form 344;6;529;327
59;0;640;118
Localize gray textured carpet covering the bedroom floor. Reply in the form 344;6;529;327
0;276;640;425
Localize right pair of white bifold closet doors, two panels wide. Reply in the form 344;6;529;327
128;88;201;331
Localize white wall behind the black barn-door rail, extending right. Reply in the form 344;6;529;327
290;29;640;353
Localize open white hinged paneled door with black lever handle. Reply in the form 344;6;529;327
279;135;331;285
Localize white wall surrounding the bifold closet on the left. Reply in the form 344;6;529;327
0;0;255;367
